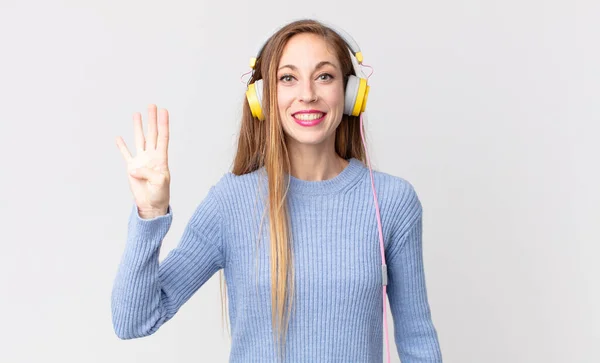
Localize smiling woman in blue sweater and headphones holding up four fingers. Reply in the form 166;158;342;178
112;20;442;363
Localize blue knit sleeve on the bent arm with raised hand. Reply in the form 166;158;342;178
111;186;225;339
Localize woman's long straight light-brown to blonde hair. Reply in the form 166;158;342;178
220;19;365;362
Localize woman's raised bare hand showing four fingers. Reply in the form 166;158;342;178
116;105;171;219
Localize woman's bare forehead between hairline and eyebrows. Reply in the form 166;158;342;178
279;33;339;67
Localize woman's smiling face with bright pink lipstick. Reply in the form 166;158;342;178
277;33;344;150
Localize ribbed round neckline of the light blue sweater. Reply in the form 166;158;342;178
286;158;365;195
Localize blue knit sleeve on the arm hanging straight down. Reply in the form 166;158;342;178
386;188;442;363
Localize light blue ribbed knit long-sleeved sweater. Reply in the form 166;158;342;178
111;158;442;363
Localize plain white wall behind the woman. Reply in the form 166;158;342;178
0;0;600;363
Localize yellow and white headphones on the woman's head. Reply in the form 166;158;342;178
246;25;370;121
